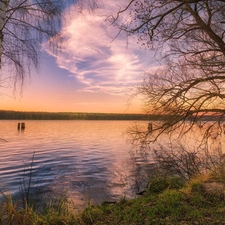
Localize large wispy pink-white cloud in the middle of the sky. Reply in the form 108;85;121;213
46;0;153;94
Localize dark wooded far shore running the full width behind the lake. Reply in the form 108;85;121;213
0;110;224;122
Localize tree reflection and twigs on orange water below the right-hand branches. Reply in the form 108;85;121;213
128;121;224;184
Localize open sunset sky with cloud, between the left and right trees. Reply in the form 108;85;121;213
0;0;155;113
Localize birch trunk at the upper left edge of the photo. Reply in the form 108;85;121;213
0;0;9;68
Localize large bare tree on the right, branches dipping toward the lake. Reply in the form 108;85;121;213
111;0;225;141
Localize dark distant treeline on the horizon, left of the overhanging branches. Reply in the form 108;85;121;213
0;110;170;120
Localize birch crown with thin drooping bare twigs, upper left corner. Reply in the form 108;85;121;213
0;0;95;89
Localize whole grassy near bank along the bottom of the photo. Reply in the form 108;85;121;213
0;175;225;225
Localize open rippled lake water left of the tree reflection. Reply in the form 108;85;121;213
0;121;147;208
